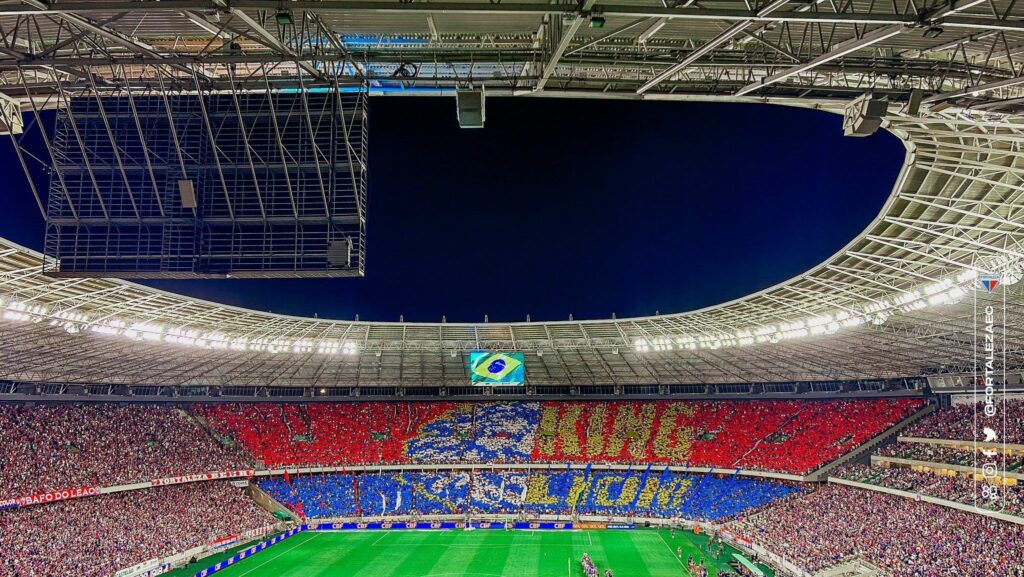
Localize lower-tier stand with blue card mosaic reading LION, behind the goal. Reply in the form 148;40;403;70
251;468;799;521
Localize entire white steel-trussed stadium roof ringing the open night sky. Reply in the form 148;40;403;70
0;0;1024;386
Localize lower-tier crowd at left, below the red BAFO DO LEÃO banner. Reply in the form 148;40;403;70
0;482;274;577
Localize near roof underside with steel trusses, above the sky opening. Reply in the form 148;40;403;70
0;0;1024;111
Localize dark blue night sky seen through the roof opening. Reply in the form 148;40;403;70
0;97;903;322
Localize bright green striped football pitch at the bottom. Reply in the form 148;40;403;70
179;529;771;577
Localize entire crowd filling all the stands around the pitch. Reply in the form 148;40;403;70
0;400;1024;577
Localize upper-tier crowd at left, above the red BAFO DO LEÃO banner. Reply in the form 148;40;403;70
0;404;252;498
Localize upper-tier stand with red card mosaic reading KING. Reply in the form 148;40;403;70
195;399;923;473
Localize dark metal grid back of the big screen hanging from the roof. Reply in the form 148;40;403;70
44;90;367;278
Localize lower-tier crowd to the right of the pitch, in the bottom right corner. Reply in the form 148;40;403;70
733;485;1024;577
